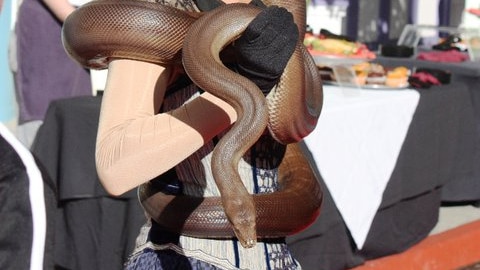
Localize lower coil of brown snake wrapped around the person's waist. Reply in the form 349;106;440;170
139;143;322;238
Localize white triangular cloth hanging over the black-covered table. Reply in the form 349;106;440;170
305;85;420;249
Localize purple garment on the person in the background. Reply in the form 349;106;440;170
16;0;92;123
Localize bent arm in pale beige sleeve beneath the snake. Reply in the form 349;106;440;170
96;60;236;195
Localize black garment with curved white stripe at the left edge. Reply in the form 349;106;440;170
0;123;56;270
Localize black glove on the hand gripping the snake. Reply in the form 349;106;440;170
233;6;299;95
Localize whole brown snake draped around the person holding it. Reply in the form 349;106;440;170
63;0;323;247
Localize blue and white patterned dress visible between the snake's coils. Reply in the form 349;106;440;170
126;74;301;270
